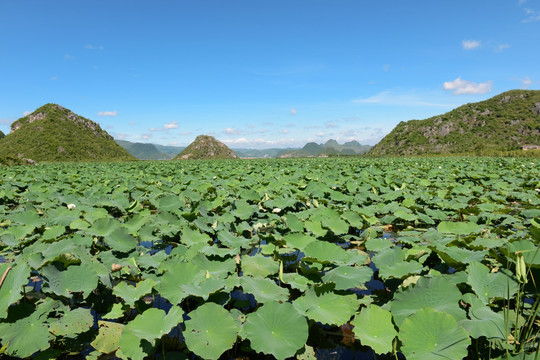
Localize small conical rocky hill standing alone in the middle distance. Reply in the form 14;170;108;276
174;135;238;160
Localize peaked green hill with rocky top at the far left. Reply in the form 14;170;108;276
0;104;135;162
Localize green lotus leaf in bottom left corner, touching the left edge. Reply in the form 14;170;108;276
0;312;49;358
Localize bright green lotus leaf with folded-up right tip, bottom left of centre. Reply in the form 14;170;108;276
126;306;183;344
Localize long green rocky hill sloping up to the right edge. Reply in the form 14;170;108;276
369;90;540;155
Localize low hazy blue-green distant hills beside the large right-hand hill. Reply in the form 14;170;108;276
276;139;371;158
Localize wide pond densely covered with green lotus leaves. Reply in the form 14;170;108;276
0;158;540;360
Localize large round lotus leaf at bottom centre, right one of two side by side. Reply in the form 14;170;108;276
244;301;308;360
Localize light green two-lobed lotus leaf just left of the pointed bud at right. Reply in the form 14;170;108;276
466;262;518;304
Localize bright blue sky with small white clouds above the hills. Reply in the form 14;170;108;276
0;0;540;148
